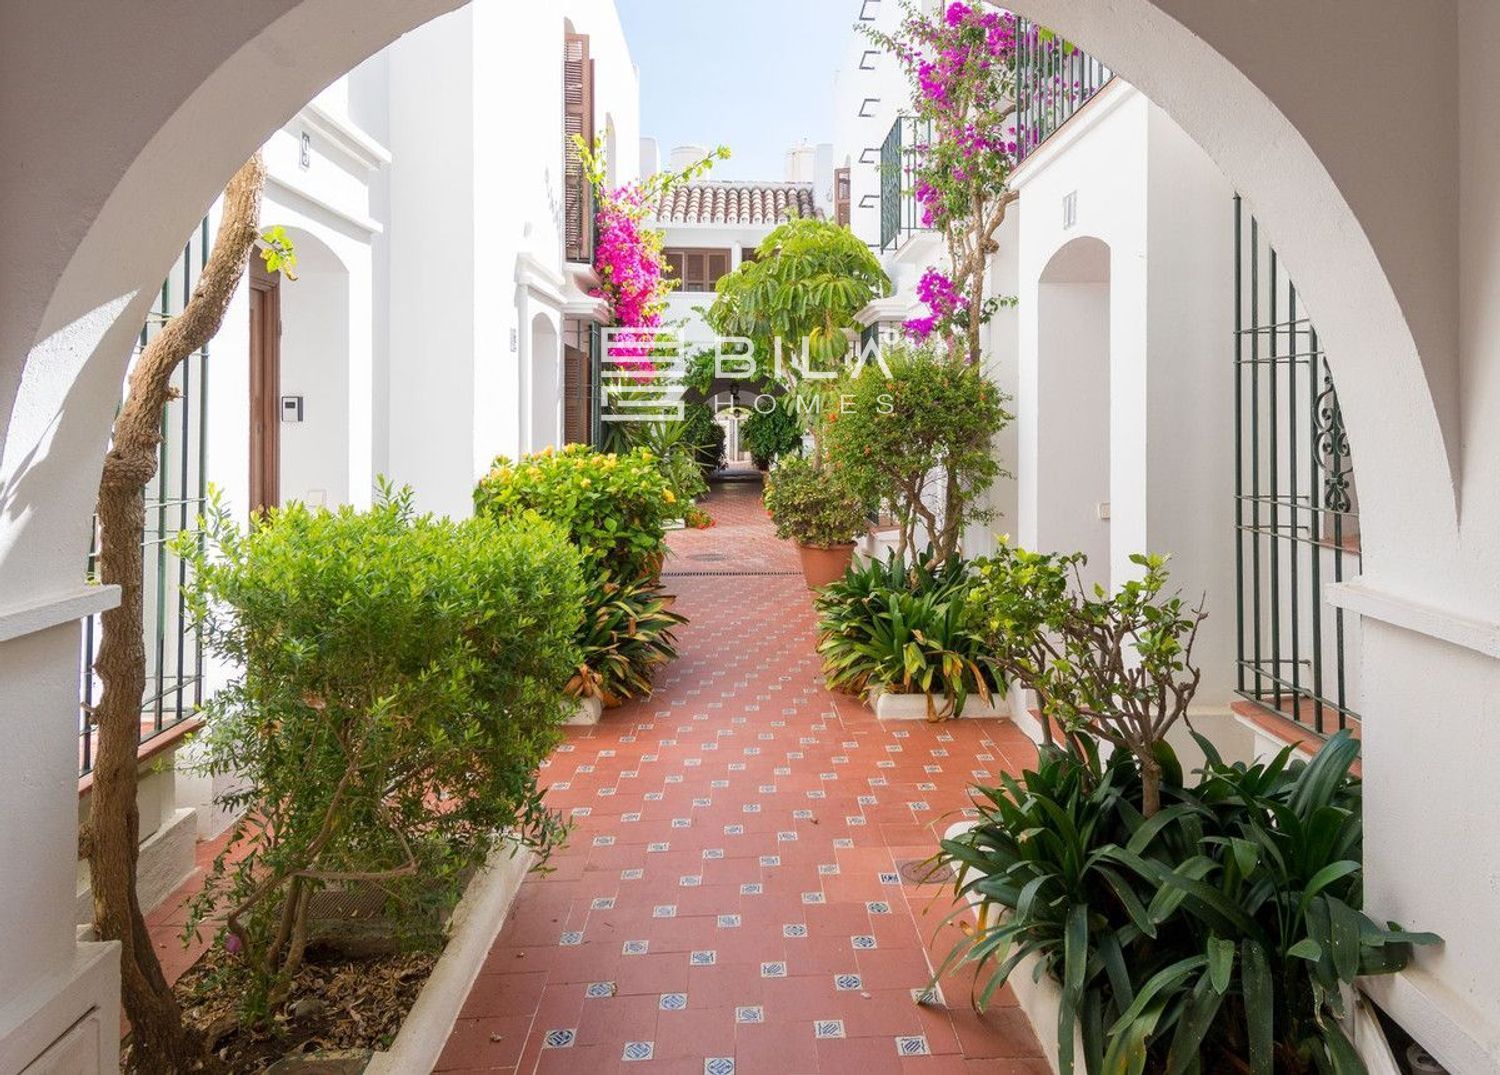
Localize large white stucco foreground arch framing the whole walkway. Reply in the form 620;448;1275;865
0;0;1500;1071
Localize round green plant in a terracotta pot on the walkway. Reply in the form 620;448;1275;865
765;456;870;589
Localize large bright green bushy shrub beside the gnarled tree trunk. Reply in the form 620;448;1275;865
176;490;582;1018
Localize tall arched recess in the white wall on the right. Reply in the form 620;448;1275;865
1025;237;1112;586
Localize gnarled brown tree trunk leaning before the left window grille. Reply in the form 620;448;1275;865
84;153;266;1072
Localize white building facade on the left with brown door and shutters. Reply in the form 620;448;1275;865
67;0;639;1037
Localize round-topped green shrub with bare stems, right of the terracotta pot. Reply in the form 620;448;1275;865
819;346;1011;558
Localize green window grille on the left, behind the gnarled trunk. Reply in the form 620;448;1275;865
78;219;209;775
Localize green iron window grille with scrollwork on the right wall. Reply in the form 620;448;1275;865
1235;195;1359;735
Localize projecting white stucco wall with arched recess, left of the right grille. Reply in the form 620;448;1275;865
1016;81;1236;708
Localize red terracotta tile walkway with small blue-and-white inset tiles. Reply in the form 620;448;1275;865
438;484;1047;1075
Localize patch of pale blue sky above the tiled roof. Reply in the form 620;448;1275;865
617;0;860;180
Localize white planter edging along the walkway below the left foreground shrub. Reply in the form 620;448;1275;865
365;844;534;1075
